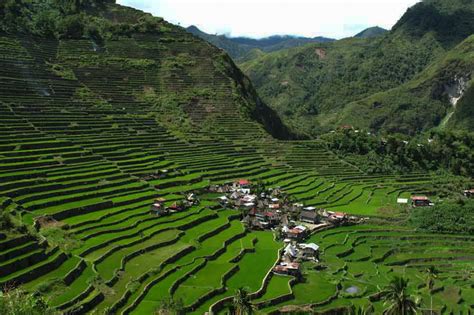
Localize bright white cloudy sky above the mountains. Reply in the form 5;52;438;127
117;0;419;38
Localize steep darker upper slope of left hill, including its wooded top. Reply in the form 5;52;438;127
0;0;289;138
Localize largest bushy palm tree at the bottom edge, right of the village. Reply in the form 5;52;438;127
380;276;417;315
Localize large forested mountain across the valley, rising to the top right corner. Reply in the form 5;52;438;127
240;0;474;136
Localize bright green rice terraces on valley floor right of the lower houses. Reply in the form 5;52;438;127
254;225;474;314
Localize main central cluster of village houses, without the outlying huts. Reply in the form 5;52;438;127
211;179;357;276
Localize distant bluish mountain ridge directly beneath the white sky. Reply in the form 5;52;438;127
187;25;334;61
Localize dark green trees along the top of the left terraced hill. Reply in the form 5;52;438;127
0;0;163;42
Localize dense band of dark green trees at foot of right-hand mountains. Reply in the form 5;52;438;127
321;129;474;177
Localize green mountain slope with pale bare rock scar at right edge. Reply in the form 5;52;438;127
338;35;474;134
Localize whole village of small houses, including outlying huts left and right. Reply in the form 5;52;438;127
150;179;452;277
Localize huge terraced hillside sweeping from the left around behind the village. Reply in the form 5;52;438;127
0;4;470;314
